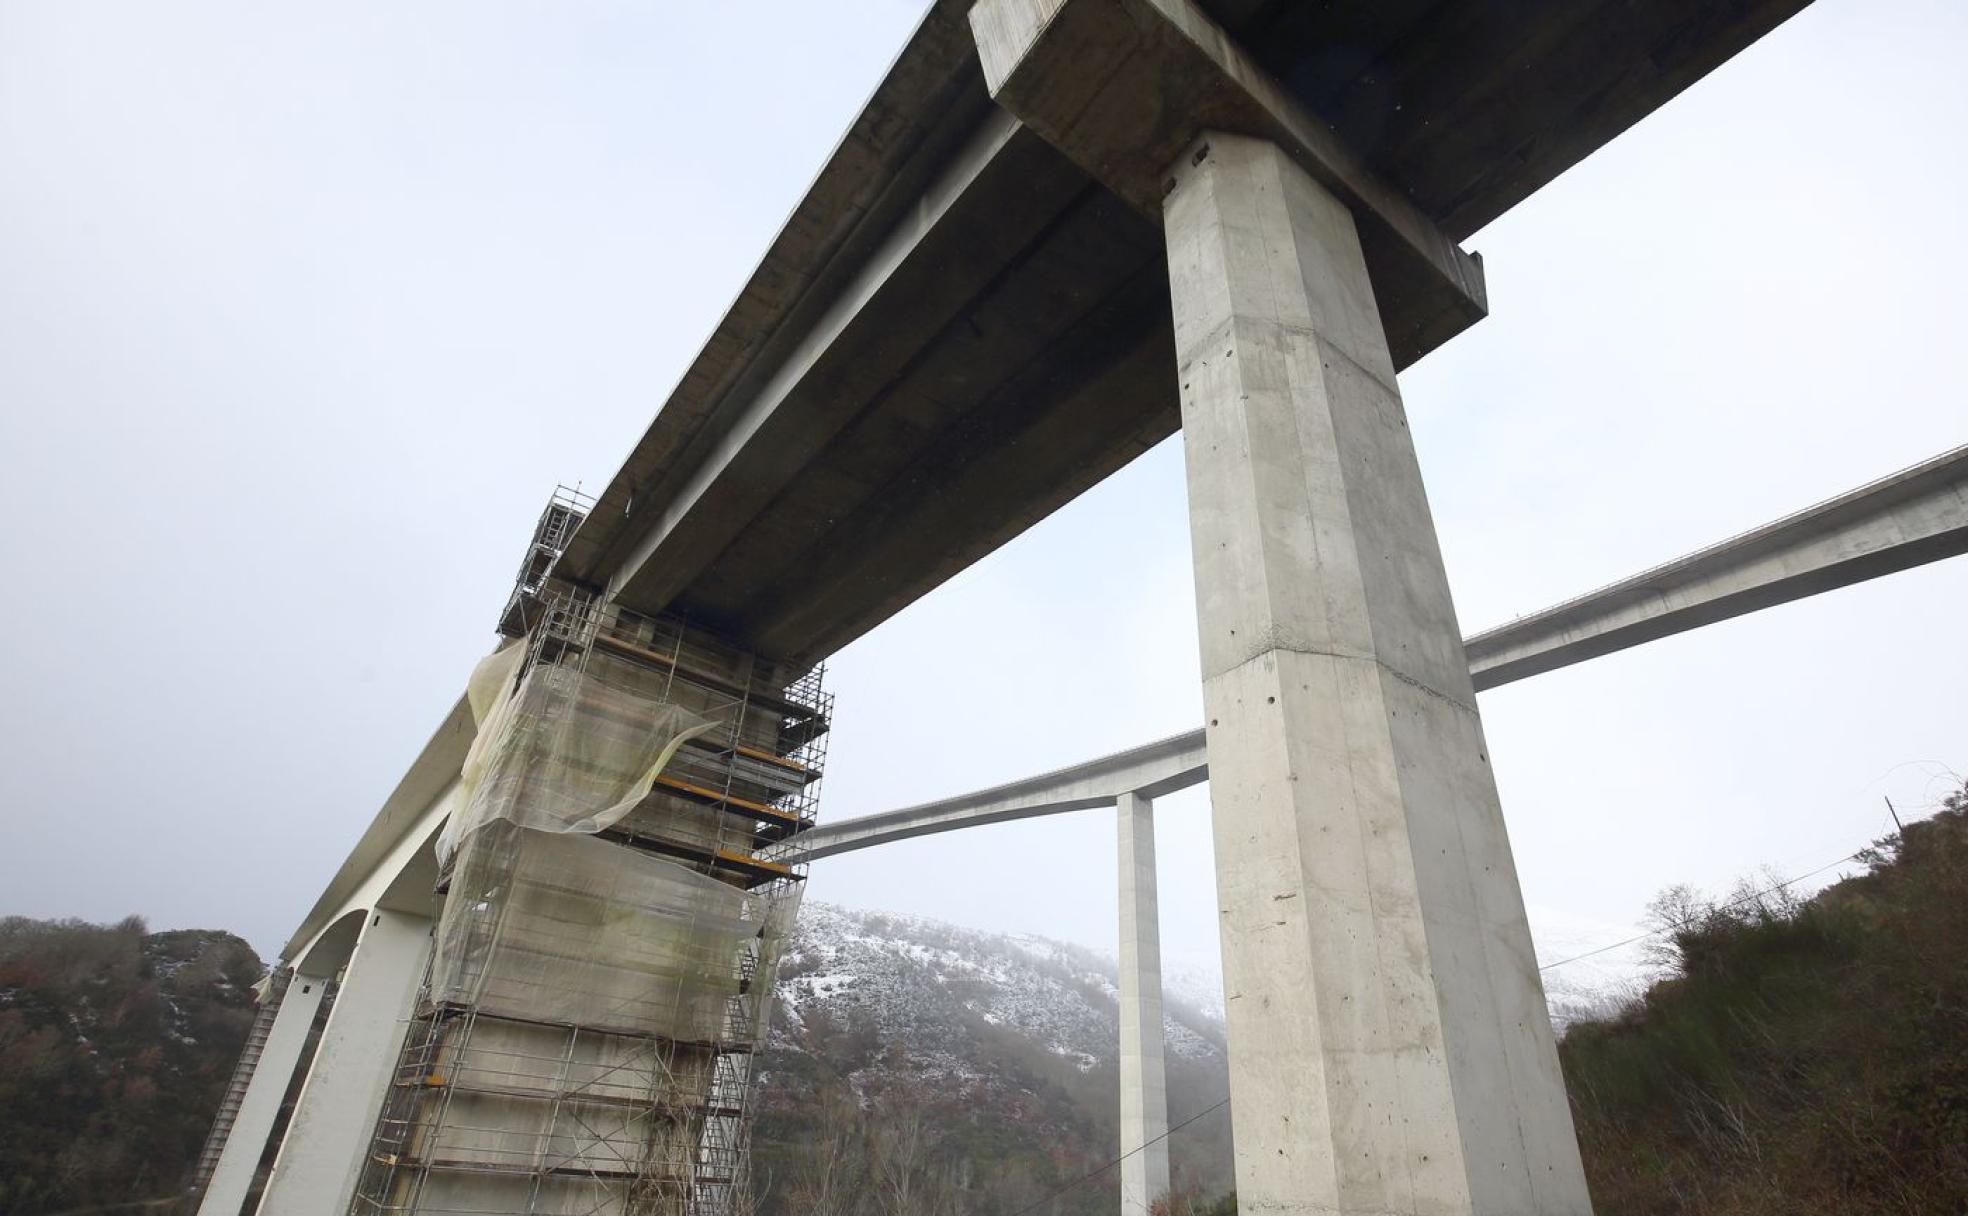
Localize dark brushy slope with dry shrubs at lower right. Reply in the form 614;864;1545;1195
1559;793;1968;1216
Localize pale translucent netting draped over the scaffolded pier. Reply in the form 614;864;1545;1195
429;645;797;1043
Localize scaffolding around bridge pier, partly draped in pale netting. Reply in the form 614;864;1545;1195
350;494;832;1216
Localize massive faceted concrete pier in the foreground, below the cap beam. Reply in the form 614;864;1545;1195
1163;132;1590;1216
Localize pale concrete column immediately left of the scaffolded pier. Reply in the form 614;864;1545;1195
258;909;431;1216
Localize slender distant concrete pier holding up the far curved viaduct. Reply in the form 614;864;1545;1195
1116;793;1169;1216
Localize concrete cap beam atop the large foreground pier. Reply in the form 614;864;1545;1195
970;0;1488;368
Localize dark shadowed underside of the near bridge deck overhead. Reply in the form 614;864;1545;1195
563;0;1803;657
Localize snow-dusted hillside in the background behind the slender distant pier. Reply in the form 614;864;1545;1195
754;903;1637;1214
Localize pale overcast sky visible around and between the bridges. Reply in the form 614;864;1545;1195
0;0;1968;979
